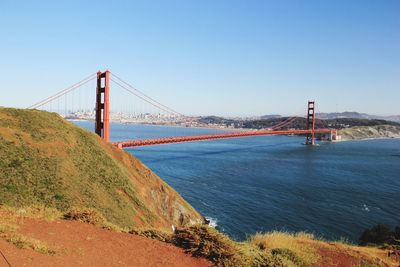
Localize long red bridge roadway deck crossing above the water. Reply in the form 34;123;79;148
112;129;334;148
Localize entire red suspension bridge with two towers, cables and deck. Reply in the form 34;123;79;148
29;70;336;148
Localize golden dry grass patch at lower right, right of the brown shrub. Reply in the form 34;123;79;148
248;231;399;266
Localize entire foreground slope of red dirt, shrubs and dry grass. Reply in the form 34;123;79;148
0;209;400;267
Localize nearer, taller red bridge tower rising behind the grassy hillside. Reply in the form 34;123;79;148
95;70;110;142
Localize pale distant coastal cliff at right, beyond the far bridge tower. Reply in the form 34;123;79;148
338;125;400;140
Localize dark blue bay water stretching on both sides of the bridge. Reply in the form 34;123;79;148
75;122;400;242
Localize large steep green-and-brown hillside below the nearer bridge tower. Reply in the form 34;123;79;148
0;108;203;229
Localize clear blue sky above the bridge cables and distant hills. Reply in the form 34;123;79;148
0;0;400;115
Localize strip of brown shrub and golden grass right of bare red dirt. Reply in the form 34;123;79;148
130;226;398;267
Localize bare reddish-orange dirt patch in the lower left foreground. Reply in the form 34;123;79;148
0;218;211;267
